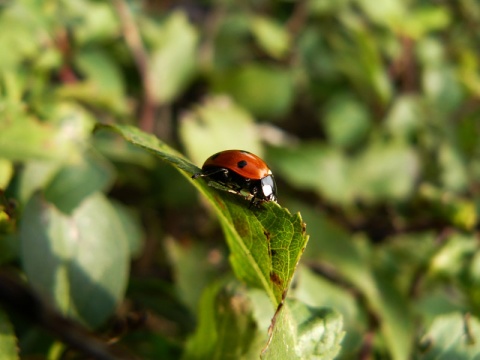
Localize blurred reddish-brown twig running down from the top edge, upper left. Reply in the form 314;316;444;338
113;0;156;132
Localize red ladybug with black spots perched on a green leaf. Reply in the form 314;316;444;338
192;150;277;206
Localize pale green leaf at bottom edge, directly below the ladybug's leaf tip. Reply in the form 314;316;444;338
262;300;345;360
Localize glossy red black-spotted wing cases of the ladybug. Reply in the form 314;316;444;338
202;150;272;180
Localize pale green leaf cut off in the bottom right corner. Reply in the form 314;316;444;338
418;313;480;360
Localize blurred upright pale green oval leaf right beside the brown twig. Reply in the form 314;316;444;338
150;11;199;104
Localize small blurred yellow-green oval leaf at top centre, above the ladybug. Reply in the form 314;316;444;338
251;16;290;59
